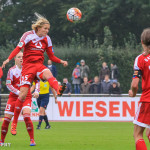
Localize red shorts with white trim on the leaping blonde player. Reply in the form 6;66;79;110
21;63;49;85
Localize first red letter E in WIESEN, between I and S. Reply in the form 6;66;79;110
83;101;93;117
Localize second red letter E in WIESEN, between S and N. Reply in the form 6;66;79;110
109;101;120;117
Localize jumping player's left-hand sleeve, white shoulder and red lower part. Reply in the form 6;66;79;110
8;32;30;60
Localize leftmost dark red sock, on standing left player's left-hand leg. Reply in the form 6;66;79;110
1;117;11;143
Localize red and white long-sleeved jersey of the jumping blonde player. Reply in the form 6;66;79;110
8;30;61;64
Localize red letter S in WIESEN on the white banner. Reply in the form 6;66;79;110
96;101;107;117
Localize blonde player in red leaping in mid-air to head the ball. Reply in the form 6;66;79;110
2;13;68;132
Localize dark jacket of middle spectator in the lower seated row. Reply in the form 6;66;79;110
90;82;101;94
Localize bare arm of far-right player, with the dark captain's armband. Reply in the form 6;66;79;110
129;70;142;97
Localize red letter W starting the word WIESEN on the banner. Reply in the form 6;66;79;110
58;101;74;117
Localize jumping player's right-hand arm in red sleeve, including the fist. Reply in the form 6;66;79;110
46;46;68;66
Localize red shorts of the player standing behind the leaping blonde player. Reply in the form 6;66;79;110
5;97;32;115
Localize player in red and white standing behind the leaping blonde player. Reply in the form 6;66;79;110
0;52;36;146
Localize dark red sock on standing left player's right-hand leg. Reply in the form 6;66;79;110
23;113;34;140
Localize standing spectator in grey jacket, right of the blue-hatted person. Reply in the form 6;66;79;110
80;59;90;83
